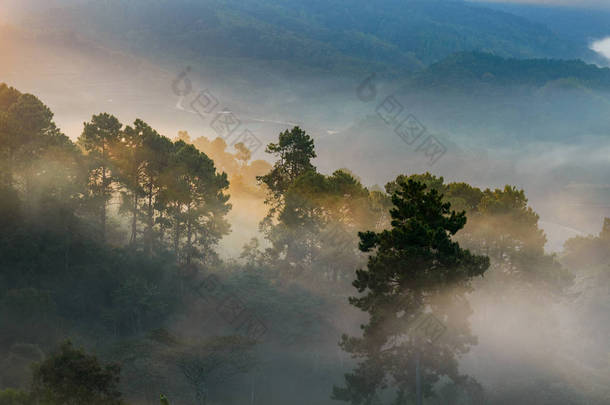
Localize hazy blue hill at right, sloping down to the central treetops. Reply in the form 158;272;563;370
318;53;610;175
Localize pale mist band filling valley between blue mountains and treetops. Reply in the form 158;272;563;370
0;22;609;251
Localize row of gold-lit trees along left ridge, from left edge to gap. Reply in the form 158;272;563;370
0;86;230;262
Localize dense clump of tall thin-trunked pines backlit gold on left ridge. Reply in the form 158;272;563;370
73;113;231;263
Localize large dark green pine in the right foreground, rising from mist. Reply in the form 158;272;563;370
333;179;489;404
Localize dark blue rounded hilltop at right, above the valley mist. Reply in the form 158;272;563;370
388;52;610;145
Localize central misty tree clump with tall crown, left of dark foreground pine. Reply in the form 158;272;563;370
256;127;388;289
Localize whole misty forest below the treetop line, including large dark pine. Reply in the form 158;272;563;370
0;84;610;405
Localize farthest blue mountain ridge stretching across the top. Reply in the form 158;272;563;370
30;0;586;72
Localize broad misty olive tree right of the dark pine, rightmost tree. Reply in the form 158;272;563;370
458;185;574;296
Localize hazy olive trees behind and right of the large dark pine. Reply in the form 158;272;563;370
386;173;573;294
